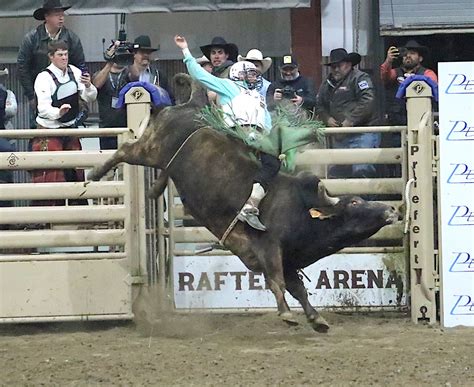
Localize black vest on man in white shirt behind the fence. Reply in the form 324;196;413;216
46;66;79;122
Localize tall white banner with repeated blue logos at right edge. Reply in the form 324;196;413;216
438;62;474;327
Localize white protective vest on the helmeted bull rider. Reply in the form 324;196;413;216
222;86;270;129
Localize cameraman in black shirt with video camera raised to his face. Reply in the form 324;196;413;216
92;41;132;149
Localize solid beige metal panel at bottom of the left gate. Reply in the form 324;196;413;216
0;257;133;321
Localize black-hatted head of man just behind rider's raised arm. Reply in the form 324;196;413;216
200;36;239;78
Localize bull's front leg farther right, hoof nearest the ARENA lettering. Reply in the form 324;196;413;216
285;269;329;333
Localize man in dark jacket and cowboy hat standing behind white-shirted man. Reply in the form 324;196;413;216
17;0;85;128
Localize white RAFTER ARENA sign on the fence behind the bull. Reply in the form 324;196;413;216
173;254;406;309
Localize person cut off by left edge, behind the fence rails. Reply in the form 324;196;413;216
0;69;17;211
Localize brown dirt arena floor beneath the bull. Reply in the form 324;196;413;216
0;313;474;386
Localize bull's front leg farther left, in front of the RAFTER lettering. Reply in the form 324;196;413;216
262;248;298;325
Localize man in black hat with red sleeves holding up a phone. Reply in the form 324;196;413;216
380;40;438;127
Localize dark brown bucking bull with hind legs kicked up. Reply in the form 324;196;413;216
88;74;398;332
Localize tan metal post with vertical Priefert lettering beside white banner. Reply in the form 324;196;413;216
406;80;438;324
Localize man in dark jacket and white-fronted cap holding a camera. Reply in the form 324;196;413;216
267;54;316;112
